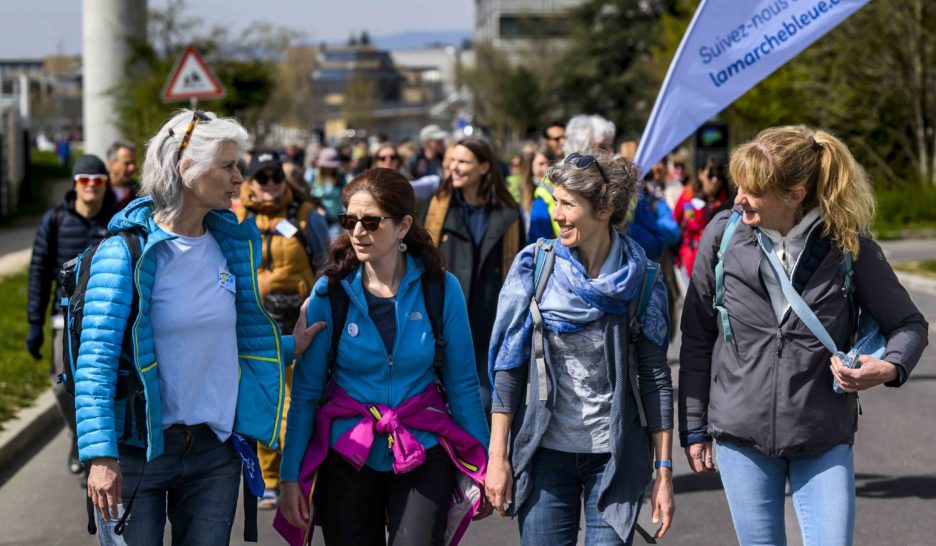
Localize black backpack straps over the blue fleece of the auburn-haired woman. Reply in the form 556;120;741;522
328;274;445;380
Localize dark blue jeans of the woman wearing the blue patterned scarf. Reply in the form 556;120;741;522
518;447;634;546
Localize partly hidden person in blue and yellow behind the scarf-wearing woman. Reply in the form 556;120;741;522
520;144;559;243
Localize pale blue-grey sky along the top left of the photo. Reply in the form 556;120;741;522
0;0;475;58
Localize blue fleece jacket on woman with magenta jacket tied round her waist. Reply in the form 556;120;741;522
280;256;489;481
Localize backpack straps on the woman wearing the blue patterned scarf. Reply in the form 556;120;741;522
527;238;660;427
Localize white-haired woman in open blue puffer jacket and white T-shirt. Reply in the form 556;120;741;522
75;110;324;545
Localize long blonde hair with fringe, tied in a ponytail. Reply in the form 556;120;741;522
729;125;876;259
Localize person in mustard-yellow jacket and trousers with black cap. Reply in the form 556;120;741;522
236;150;328;510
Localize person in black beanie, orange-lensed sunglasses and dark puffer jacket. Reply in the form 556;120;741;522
26;154;117;480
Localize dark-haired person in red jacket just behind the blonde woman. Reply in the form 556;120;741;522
673;157;732;279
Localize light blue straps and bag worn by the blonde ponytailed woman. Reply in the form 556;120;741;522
714;211;887;394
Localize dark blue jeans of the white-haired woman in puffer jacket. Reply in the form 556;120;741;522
97;425;241;546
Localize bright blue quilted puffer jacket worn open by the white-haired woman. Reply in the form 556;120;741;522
75;197;295;463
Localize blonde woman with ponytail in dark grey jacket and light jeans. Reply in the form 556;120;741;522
679;127;928;546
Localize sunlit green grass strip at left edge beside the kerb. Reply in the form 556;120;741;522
0;271;52;428
